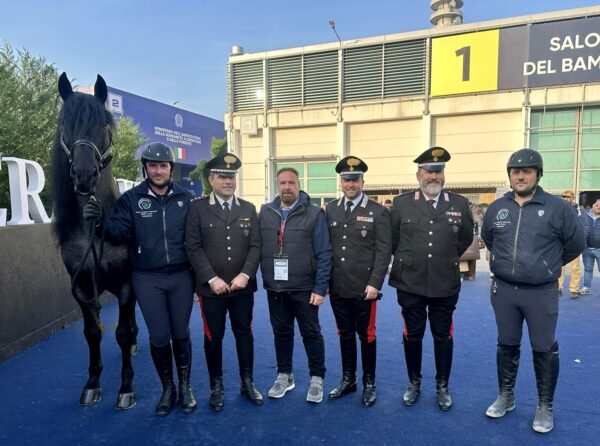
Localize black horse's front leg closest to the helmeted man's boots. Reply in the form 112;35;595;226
115;286;136;409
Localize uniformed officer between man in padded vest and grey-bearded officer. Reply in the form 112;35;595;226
326;156;392;407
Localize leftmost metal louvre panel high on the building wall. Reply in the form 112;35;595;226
231;60;264;111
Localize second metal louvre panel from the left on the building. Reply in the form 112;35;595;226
267;56;302;108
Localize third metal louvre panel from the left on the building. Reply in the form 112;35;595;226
304;51;338;105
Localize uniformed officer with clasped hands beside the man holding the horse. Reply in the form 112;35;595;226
185;153;263;411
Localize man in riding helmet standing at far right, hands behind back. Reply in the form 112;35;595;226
481;149;585;433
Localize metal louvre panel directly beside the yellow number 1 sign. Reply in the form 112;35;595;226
383;39;426;97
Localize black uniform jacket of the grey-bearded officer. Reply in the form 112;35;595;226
390;190;473;297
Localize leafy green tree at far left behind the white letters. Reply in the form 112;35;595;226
0;42;59;213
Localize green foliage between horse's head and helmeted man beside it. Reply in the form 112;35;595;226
112;117;146;181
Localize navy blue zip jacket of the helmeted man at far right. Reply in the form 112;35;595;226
481;186;585;285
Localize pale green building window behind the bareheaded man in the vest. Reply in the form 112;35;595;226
275;161;338;206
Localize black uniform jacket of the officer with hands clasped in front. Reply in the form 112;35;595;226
185;193;261;297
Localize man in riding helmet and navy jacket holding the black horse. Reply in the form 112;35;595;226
84;142;196;416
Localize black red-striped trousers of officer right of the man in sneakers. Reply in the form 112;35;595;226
331;296;377;381
